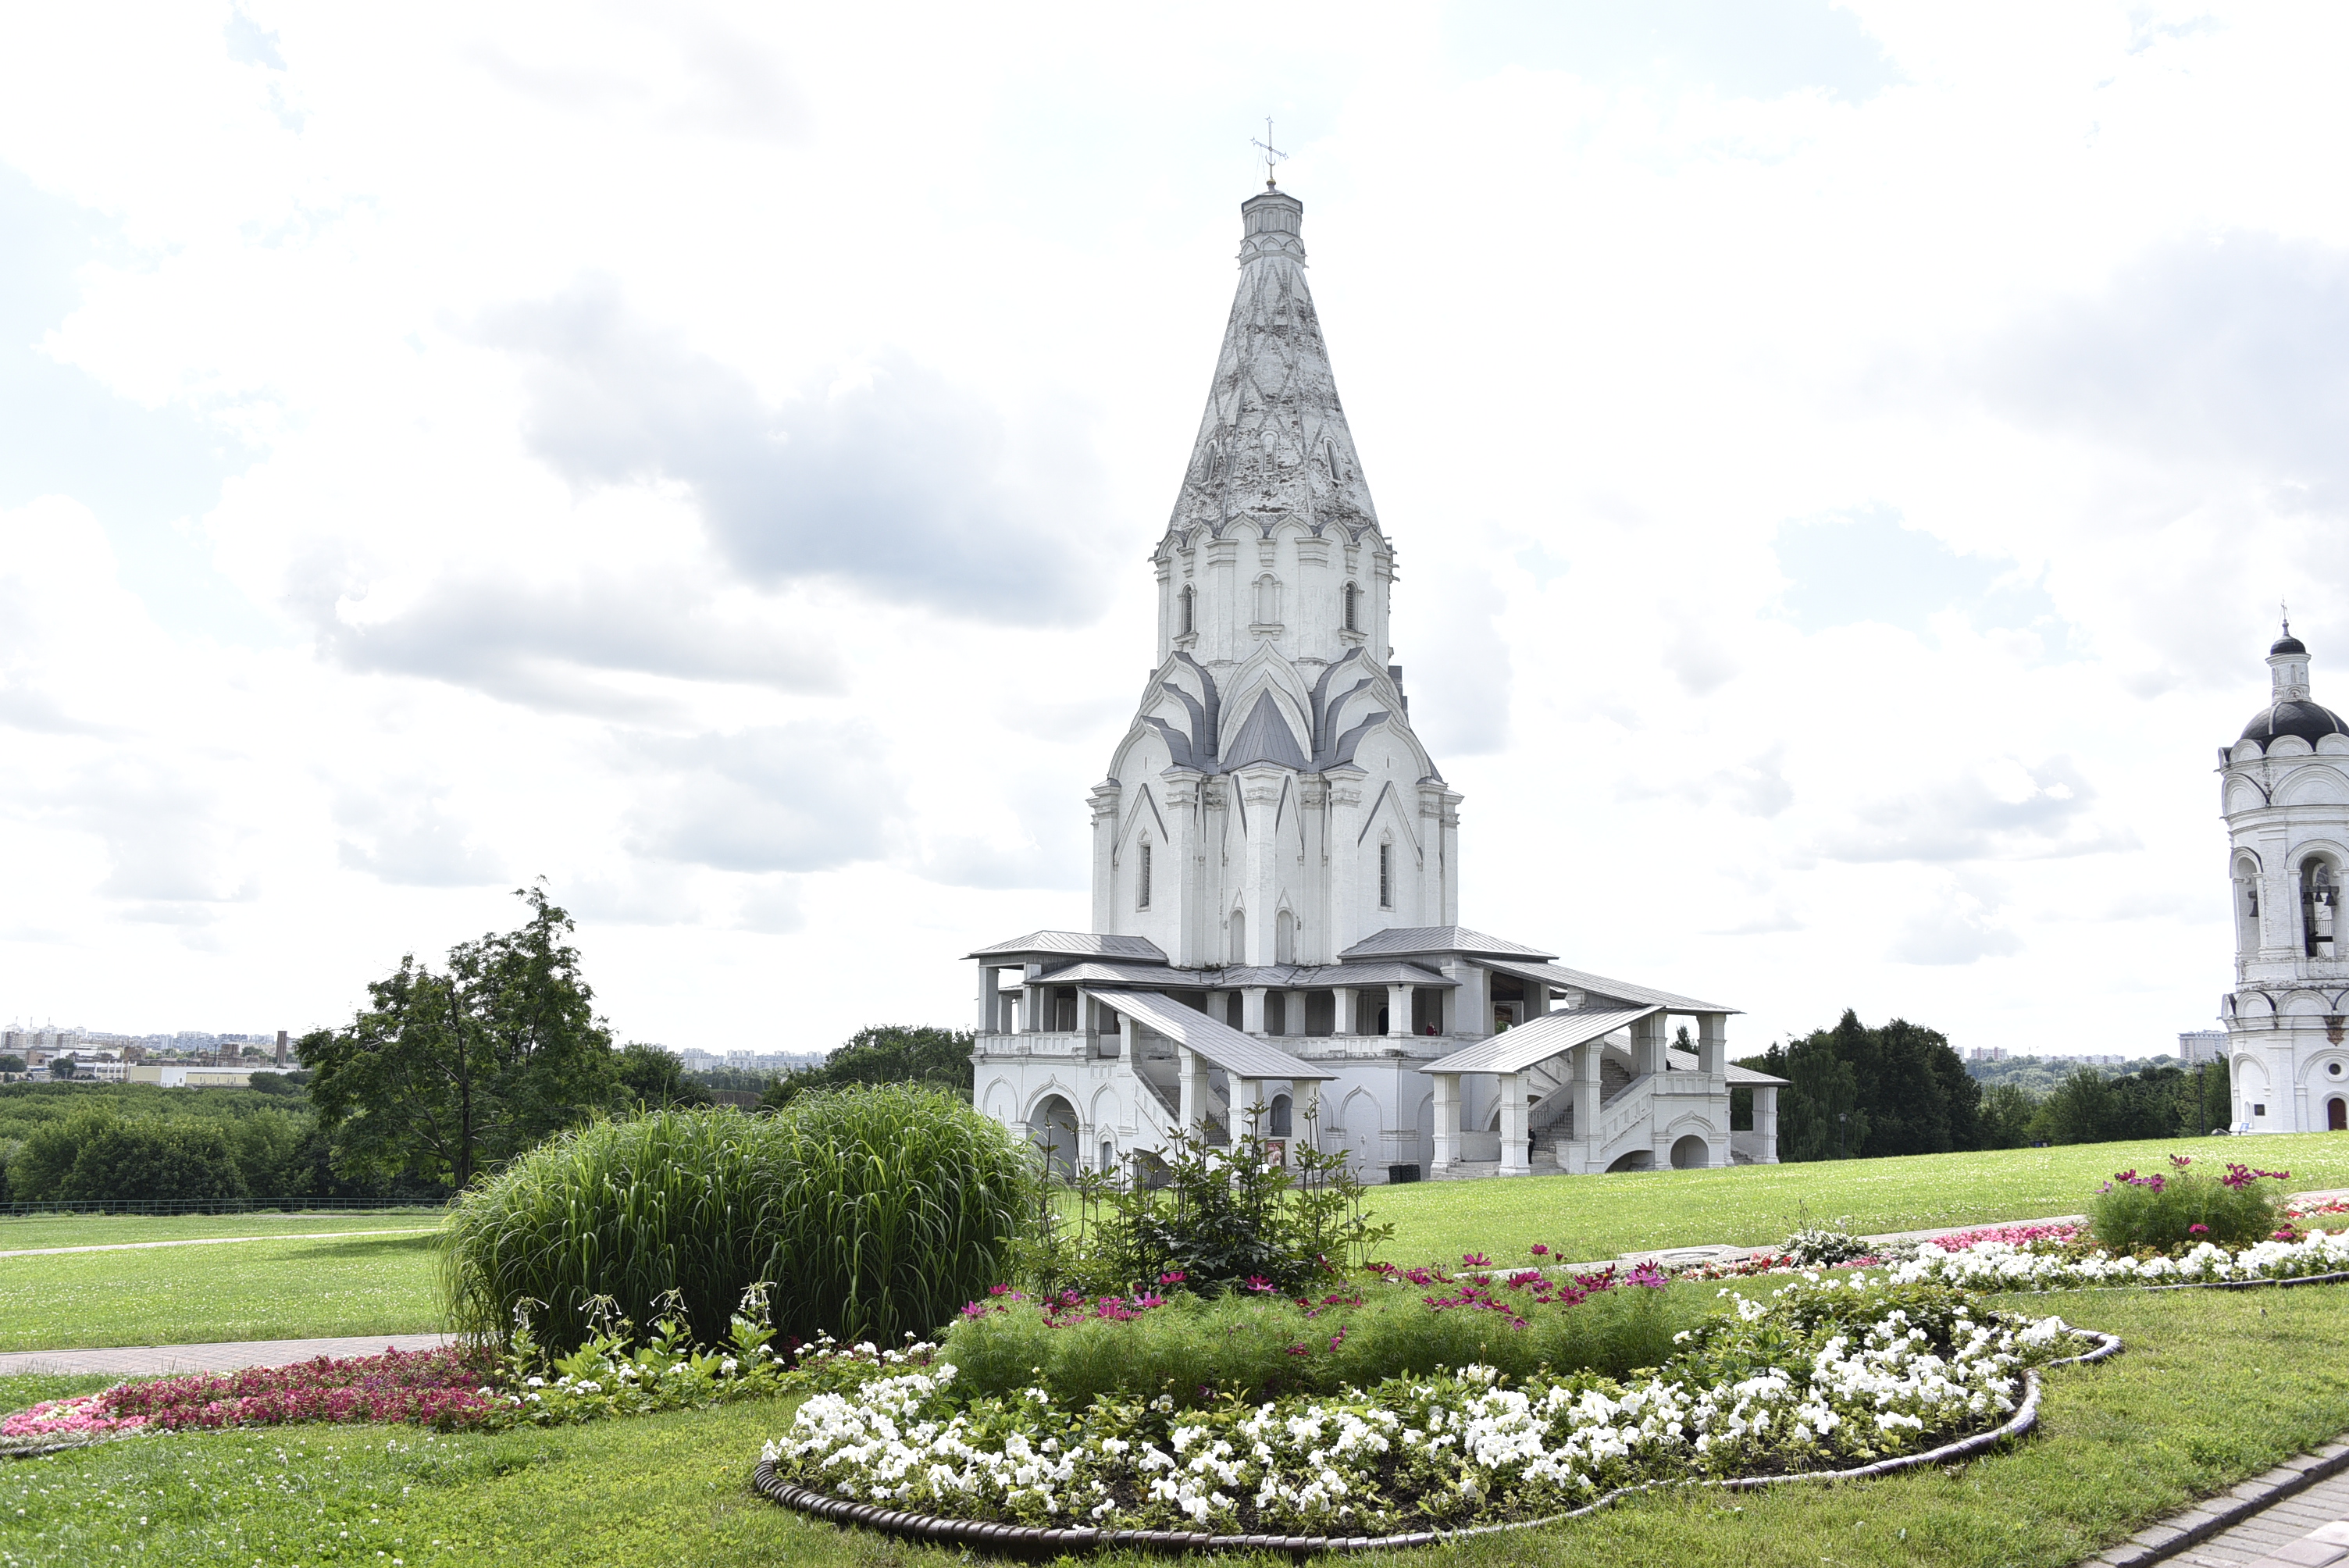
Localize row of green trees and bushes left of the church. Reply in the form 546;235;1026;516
0;885;972;1202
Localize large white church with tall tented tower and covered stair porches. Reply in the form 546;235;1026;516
970;185;1783;1181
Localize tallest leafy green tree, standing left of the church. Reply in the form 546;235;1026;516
301;882;618;1190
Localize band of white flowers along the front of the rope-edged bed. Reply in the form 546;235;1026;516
761;1279;2081;1535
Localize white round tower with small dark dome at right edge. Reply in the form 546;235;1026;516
2218;622;2349;1131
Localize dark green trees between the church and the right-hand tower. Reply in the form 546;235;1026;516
1738;1010;2227;1162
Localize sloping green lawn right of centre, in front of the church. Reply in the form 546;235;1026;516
1370;1131;2349;1263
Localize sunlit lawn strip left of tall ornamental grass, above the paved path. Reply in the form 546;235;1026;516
0;1235;439;1349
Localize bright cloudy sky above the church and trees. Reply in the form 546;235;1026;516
0;0;2349;1054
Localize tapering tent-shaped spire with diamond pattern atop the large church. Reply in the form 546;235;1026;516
1167;190;1379;537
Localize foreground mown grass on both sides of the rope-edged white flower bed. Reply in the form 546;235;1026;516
0;1286;2349;1568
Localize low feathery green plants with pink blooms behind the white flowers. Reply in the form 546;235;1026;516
939;1284;1717;1409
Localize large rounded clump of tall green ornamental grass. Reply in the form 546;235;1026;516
444;1085;1034;1352
